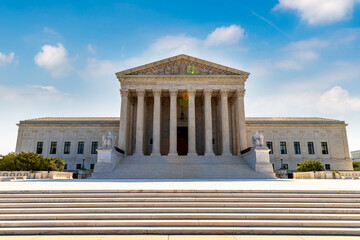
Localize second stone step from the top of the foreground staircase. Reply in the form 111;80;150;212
0;197;360;203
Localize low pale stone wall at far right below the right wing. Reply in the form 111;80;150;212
293;171;360;179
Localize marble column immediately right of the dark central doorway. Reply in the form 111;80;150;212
187;89;197;156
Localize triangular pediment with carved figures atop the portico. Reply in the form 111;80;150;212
116;54;249;77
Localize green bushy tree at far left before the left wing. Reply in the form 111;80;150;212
0;152;65;171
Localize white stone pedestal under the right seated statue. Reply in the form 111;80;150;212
242;147;274;173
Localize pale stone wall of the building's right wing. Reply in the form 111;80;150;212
247;119;353;171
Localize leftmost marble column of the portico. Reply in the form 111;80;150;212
118;89;129;151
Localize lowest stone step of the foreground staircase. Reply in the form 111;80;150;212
0;227;360;236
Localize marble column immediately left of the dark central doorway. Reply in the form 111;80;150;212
169;89;178;156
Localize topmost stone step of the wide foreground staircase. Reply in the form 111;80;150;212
0;192;360;199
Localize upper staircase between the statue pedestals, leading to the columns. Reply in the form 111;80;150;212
92;156;275;180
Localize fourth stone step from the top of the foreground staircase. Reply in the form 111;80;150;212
0;207;360;214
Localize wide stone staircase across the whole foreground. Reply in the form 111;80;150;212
0;190;360;235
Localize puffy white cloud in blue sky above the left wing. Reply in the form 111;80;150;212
34;43;71;78
